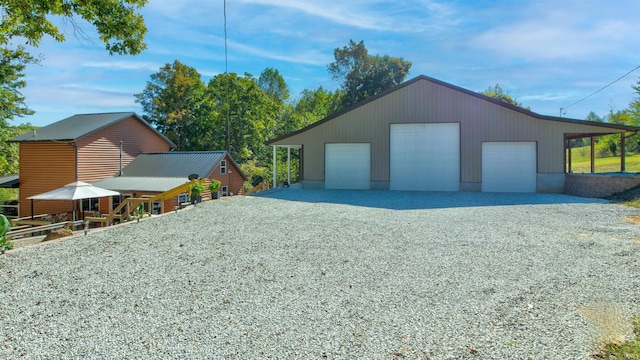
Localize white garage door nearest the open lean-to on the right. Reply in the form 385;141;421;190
482;142;537;192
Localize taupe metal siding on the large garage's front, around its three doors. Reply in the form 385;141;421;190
274;80;621;183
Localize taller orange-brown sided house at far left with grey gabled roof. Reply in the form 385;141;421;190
10;112;175;217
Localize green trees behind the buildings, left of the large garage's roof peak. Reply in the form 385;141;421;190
135;40;411;185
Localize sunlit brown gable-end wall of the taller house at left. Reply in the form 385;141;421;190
78;117;169;182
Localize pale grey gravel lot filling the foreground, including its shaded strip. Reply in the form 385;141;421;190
0;189;640;359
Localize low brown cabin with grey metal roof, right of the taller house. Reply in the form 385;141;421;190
93;151;247;213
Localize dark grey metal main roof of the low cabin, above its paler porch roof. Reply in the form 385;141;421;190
121;151;247;180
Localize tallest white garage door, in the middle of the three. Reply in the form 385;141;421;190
389;123;460;191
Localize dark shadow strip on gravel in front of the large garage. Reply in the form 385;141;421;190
252;189;609;210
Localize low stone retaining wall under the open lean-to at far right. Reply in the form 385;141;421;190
564;174;640;197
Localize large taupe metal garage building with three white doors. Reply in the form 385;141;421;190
267;76;640;193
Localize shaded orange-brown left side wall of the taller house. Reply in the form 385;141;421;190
20;142;76;217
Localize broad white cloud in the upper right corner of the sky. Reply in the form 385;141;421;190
471;2;640;62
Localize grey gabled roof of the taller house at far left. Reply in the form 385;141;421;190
9;112;175;147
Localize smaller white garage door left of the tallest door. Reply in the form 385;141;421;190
324;144;371;189
